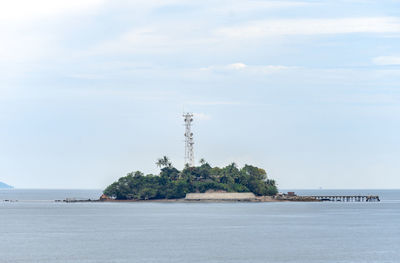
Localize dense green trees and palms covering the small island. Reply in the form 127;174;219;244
104;156;277;200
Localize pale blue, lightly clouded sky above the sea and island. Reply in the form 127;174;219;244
0;0;400;189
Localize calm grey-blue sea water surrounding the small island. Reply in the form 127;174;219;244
0;190;400;263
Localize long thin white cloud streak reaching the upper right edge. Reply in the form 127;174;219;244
216;17;400;38
